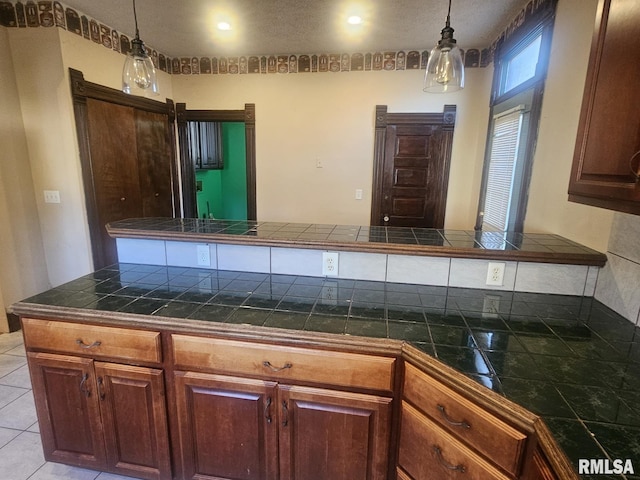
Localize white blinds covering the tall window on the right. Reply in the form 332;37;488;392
483;105;524;231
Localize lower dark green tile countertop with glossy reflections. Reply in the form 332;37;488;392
16;264;640;479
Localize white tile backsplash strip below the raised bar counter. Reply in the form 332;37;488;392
117;239;600;296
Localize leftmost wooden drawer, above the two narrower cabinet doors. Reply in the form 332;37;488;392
22;318;162;363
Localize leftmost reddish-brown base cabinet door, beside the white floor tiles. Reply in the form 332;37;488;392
27;352;105;470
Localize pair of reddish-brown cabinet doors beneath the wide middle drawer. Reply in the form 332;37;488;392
175;372;392;480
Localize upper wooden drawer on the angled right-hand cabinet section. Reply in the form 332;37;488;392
404;364;527;475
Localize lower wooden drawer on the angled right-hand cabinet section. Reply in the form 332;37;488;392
398;402;509;480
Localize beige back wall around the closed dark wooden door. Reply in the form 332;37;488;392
173;69;491;228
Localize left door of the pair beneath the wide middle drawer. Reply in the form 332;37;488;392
175;372;278;480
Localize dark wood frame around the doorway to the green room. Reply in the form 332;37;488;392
176;103;257;221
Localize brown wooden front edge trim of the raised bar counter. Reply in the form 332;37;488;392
106;224;607;267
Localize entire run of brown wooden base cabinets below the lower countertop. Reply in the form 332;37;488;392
21;316;578;480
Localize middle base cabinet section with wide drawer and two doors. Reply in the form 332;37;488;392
173;335;395;480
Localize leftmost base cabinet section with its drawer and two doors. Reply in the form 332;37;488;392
22;318;172;480
